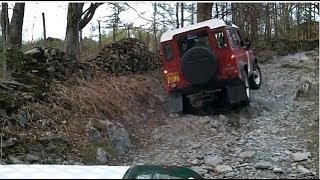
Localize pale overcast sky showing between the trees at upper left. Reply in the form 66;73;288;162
9;1;156;41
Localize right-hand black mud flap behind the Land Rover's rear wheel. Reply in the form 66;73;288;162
227;84;246;104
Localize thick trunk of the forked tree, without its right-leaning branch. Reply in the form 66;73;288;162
64;3;81;61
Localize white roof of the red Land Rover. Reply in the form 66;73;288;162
160;19;239;42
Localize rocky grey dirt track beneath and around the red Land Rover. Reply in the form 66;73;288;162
114;51;319;179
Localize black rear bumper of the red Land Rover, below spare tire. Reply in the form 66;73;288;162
168;78;242;95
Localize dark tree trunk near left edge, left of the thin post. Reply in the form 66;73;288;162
7;3;25;51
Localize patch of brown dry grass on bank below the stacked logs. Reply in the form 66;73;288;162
54;72;149;119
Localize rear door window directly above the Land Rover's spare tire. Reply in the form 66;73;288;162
178;31;210;57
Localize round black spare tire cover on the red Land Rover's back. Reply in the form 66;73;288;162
181;46;218;85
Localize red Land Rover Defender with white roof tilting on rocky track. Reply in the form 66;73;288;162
160;19;261;113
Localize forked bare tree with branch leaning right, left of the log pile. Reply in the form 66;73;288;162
64;3;103;61
